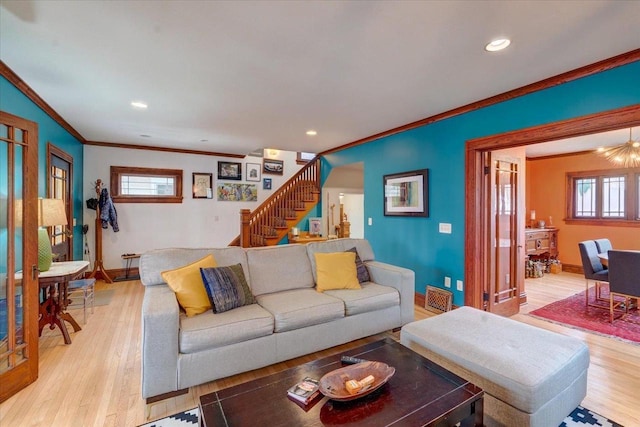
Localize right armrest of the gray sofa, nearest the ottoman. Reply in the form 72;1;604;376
365;261;416;325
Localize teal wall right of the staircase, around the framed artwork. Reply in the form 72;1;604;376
321;62;640;305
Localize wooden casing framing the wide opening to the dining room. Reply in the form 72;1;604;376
464;104;640;309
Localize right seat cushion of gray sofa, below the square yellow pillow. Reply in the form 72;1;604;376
325;282;400;316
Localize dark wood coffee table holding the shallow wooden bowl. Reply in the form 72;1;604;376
200;339;484;427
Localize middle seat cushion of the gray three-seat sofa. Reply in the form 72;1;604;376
256;289;344;332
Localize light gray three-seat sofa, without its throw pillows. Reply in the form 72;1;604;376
139;239;415;402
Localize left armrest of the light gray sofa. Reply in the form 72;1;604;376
142;285;180;398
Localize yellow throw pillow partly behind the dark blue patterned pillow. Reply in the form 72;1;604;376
161;255;217;317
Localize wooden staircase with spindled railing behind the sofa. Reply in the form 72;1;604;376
229;157;320;248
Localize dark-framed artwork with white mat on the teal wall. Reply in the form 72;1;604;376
383;169;429;217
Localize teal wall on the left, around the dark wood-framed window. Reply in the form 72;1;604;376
0;76;84;259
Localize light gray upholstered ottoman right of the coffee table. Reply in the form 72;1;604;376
400;307;589;427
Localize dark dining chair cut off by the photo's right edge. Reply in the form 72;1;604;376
609;250;640;323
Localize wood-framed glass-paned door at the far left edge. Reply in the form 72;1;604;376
0;112;38;402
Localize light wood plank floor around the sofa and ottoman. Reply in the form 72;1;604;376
0;273;640;427
